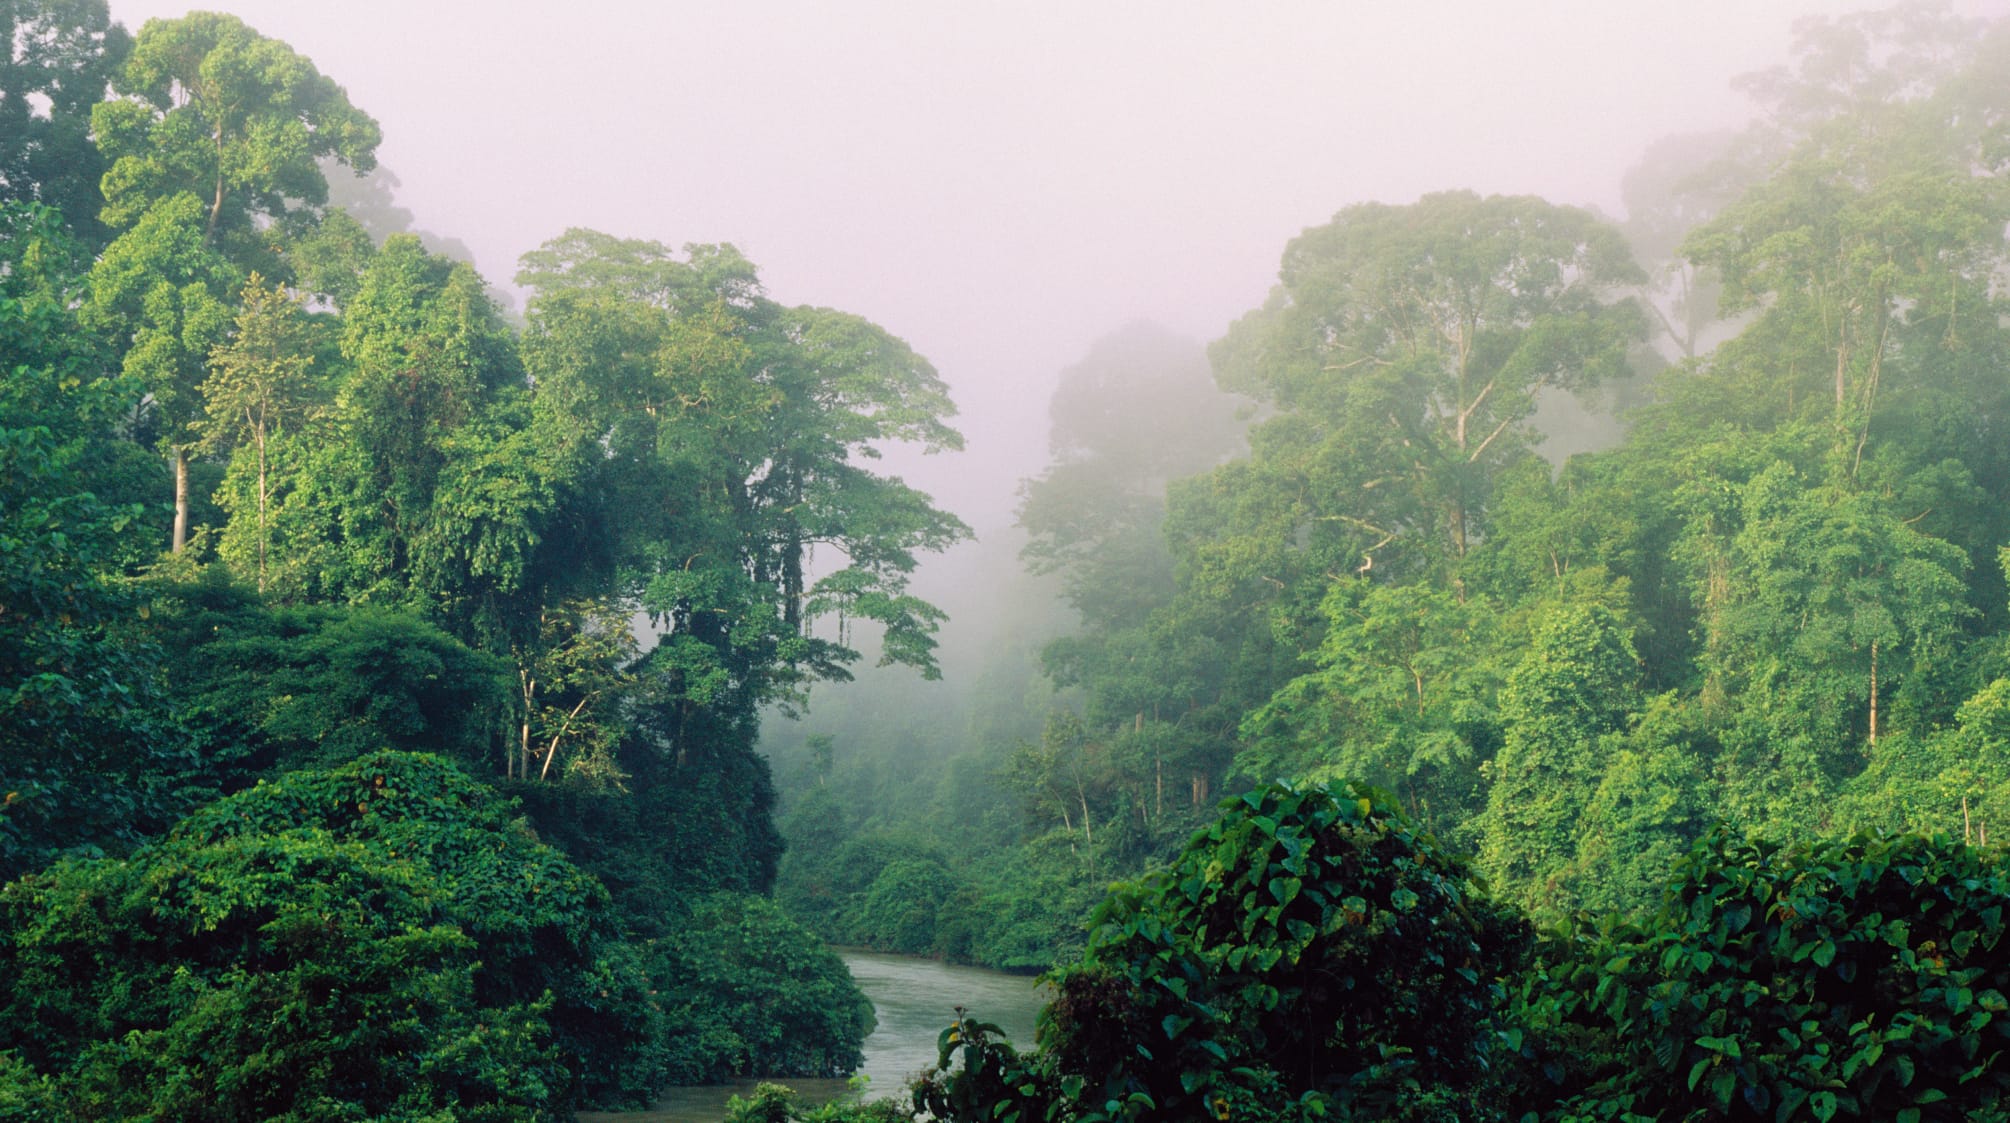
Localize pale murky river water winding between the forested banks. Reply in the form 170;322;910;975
579;950;1045;1123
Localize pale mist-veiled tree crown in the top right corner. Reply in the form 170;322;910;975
1684;4;2010;447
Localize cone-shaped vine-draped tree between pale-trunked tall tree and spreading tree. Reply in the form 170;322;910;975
269;235;558;653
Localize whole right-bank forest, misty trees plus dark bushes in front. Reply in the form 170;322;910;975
759;6;2010;1123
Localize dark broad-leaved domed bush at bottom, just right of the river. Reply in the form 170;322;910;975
923;785;1528;1119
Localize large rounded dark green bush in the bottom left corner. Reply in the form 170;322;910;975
0;753;637;1121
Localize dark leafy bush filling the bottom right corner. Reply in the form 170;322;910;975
1534;832;2010;1123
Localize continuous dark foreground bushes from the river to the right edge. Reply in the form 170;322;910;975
915;785;2010;1123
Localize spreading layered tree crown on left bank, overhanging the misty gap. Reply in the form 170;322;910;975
519;231;969;701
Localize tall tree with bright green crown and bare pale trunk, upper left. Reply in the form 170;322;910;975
90;12;378;550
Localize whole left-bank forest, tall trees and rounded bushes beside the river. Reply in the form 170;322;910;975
0;0;967;1119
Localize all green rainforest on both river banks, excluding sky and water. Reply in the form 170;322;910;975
11;0;2010;1121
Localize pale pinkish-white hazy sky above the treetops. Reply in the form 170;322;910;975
94;0;1905;528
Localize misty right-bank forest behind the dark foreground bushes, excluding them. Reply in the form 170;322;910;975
778;6;2010;968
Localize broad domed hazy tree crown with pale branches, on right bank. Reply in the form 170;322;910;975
1214;193;1644;573
